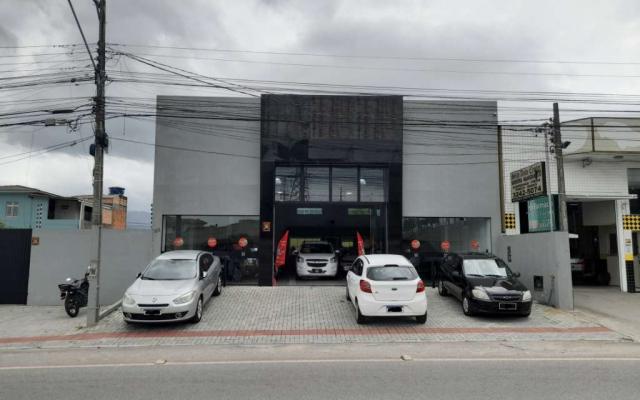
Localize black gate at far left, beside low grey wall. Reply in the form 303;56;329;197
0;229;31;304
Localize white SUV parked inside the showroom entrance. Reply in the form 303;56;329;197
296;242;338;277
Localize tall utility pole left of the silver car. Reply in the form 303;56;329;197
87;0;107;326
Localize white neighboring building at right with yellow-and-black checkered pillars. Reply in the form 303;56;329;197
502;117;640;292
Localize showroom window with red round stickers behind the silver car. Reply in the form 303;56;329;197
162;215;260;283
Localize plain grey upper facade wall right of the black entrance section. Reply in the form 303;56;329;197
402;101;500;248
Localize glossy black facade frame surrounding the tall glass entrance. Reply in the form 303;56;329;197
258;95;404;285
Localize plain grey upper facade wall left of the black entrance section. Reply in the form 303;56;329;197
153;96;260;254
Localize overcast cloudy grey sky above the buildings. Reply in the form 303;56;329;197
0;0;640;220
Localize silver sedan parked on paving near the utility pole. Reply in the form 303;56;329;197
122;250;222;323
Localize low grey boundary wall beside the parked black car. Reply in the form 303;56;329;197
496;232;573;310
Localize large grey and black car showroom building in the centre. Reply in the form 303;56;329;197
153;95;500;285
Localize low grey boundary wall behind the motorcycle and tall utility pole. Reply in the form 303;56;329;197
27;229;152;305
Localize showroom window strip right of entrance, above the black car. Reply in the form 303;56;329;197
402;217;491;253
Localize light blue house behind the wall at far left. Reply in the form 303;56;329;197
0;185;91;229
